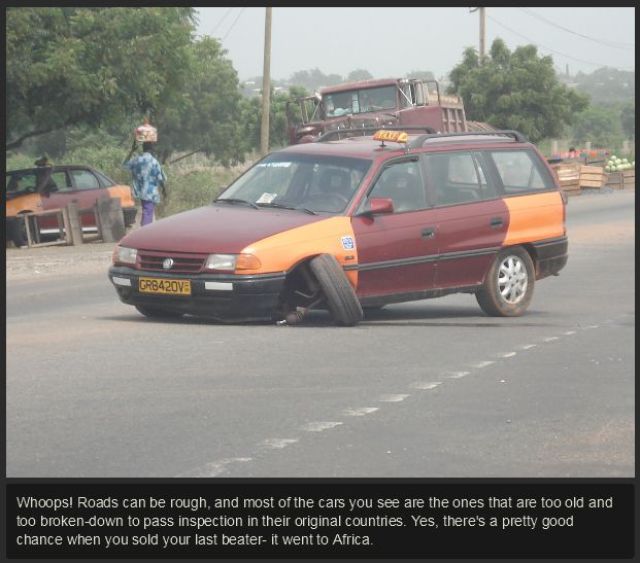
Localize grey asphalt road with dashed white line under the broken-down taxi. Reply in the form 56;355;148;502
6;191;635;477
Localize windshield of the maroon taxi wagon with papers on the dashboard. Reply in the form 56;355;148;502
216;152;371;213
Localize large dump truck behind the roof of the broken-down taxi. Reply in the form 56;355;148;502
286;78;472;144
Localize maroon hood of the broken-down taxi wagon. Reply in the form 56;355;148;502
119;203;326;254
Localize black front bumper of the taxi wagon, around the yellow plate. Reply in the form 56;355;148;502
108;266;285;321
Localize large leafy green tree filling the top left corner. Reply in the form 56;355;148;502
6;7;195;150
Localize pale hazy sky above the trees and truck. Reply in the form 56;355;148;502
198;7;635;80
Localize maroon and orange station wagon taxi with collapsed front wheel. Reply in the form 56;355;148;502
109;130;568;325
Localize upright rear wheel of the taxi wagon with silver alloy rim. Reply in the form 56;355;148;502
476;247;536;317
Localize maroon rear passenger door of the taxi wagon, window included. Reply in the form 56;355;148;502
423;150;509;288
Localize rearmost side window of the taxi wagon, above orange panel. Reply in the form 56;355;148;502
489;151;555;195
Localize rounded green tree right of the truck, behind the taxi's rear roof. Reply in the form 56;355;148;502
449;39;589;143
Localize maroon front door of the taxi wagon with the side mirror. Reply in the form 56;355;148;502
352;157;437;298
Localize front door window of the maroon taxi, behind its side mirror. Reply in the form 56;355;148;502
368;160;427;213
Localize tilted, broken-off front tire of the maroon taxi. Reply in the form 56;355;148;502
309;254;364;326
